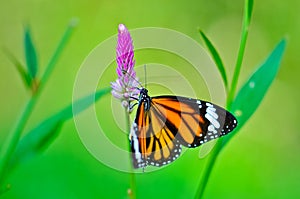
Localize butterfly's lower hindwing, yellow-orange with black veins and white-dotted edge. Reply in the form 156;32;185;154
130;100;181;168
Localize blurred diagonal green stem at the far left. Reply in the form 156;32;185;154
0;20;76;184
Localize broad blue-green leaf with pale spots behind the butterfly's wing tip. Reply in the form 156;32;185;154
224;39;286;146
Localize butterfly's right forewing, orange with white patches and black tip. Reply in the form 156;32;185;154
152;96;237;148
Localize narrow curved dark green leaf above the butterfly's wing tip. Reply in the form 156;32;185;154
199;30;228;89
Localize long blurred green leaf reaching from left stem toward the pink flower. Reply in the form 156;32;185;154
10;88;111;168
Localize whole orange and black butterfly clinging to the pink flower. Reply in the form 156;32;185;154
129;88;237;168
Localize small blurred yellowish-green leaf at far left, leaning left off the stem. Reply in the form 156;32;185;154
3;49;31;88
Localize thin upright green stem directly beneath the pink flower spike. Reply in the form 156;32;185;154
125;108;136;199
